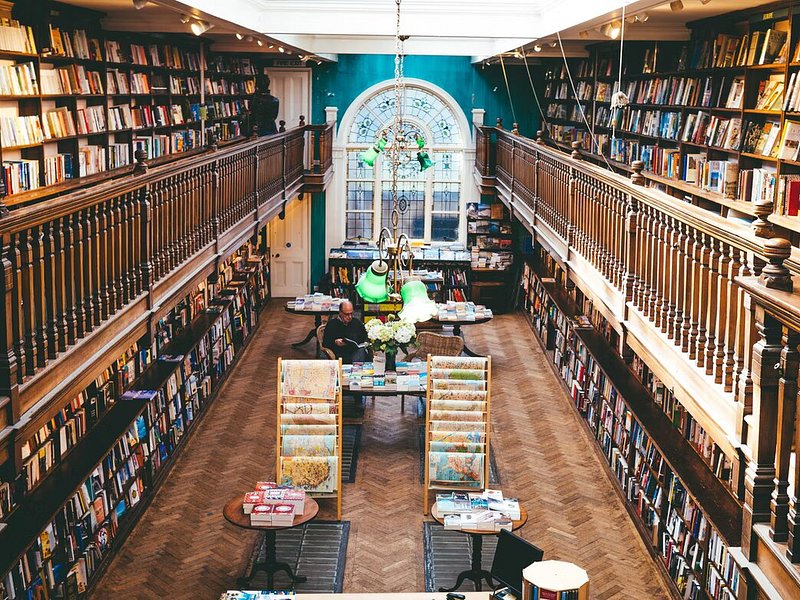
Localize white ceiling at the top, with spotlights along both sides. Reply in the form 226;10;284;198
56;0;758;60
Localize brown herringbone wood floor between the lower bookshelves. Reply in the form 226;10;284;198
93;301;669;600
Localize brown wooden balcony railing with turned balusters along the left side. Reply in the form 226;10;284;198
0;126;318;423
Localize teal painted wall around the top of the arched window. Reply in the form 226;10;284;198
311;54;539;137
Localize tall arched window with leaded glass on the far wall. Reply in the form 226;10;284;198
345;82;470;242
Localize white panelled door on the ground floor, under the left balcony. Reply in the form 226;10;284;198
269;195;311;298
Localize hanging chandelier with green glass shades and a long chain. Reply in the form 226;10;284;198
356;0;437;323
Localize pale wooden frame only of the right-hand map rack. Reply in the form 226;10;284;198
423;354;492;515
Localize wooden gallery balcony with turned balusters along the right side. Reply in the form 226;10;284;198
474;127;800;598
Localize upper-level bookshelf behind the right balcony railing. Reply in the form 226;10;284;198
544;2;800;245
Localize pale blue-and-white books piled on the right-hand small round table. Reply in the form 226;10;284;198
436;490;520;531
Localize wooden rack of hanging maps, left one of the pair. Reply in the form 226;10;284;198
275;358;342;519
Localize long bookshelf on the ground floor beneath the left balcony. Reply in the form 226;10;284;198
0;236;268;598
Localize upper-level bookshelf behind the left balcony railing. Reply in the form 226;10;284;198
0;3;255;205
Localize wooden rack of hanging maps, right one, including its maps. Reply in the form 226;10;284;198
423;355;492;515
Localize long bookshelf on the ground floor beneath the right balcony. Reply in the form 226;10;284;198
522;249;741;599
